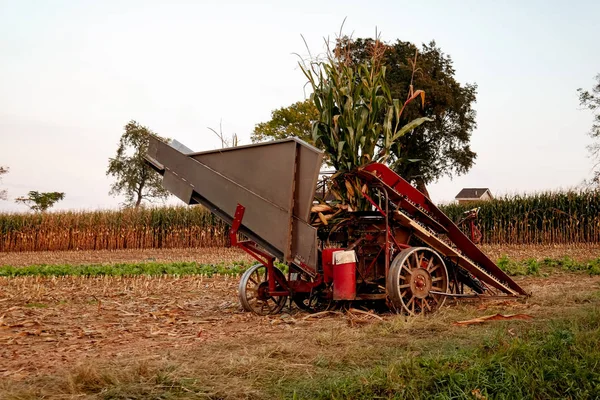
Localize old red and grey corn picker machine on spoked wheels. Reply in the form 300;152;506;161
146;137;527;315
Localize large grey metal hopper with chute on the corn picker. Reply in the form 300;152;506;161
145;137;323;271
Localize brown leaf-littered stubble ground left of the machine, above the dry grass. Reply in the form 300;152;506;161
0;277;262;376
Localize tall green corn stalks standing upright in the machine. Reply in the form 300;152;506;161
300;38;431;214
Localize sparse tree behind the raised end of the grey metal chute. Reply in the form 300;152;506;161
106;120;169;208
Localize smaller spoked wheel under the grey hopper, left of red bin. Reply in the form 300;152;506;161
238;264;287;315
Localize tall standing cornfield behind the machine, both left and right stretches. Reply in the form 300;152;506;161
0;191;600;252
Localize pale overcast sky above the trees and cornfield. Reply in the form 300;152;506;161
0;0;600;210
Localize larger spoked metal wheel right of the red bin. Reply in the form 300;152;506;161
386;247;448;315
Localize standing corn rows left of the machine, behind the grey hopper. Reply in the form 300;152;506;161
0;206;228;252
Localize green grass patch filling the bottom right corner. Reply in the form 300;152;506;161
276;307;600;399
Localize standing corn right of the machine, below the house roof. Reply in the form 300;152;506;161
441;191;600;244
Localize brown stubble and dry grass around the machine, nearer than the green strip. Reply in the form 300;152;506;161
0;272;600;399
